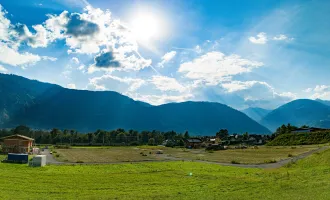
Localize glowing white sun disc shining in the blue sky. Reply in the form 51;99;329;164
132;14;162;41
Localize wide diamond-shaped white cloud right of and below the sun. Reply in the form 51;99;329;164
178;51;263;85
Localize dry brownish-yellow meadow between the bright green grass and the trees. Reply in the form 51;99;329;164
55;145;318;164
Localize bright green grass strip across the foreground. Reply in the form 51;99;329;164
0;150;330;199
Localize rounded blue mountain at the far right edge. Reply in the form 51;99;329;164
260;99;330;131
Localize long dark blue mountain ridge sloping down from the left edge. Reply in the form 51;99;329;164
0;74;270;135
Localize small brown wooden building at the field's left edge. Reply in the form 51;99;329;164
0;134;34;153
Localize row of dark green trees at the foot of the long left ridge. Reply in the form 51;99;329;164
0;125;190;145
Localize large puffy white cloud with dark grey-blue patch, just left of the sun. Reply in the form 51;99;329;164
45;6;151;73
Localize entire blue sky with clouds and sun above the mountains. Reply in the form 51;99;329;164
0;0;330;109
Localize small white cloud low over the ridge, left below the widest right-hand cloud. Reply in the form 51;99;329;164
150;75;186;92
